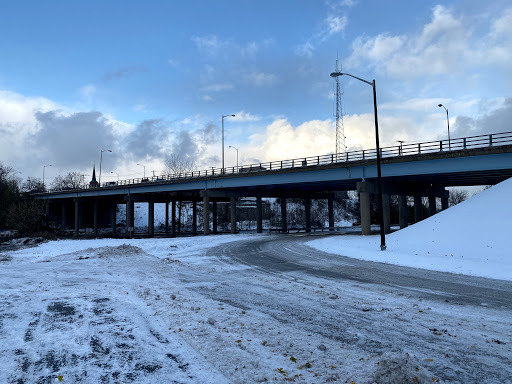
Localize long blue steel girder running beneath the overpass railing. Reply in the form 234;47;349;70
36;145;512;201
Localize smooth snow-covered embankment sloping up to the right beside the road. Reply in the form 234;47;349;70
308;179;512;280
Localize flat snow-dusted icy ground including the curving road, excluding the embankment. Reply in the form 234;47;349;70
0;235;512;384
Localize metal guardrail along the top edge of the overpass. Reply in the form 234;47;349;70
48;132;512;193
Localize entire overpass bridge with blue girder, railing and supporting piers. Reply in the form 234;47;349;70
36;132;512;236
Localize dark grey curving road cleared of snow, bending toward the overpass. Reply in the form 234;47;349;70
208;234;512;309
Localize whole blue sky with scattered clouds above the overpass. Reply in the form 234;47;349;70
0;0;512;182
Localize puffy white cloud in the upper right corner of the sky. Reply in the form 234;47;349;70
345;5;512;78
